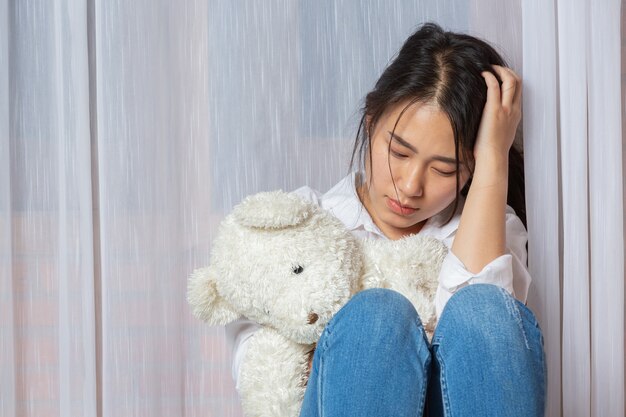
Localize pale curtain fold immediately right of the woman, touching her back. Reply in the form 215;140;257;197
522;1;563;416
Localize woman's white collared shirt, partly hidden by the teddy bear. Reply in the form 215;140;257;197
226;173;531;390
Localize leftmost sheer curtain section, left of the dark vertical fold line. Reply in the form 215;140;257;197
0;1;96;415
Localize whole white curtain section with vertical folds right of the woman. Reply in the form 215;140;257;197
522;0;625;417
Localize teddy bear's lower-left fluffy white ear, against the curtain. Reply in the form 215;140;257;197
187;266;241;325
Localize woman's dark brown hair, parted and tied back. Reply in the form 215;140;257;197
350;23;526;226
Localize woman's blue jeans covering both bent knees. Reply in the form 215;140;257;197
300;284;547;417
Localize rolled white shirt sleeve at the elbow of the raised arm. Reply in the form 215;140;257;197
435;207;531;320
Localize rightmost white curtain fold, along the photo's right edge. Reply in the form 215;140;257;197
587;0;625;417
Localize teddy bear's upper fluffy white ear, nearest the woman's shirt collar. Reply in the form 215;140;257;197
232;190;313;229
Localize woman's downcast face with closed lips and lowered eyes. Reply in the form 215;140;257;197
359;102;469;239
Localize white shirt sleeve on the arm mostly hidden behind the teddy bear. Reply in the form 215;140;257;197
226;186;321;391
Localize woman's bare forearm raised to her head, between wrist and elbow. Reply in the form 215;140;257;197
451;154;508;273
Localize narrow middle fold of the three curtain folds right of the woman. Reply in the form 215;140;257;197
557;0;591;416
